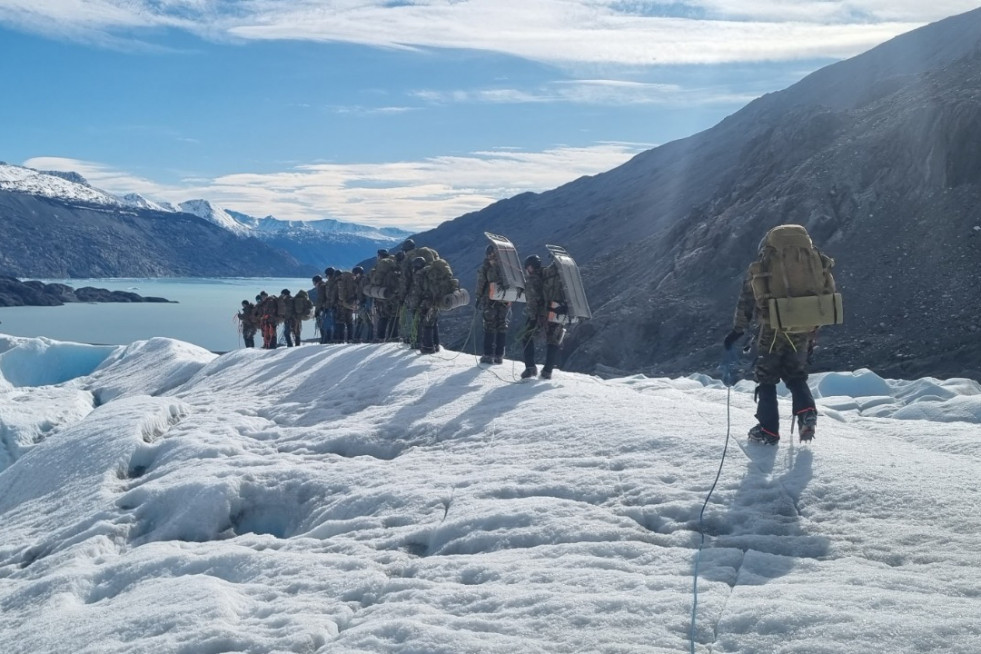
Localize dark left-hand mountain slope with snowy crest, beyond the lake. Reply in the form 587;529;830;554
0;163;311;278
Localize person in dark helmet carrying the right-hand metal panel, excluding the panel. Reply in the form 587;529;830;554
520;254;565;379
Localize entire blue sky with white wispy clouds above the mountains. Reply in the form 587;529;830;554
0;0;977;230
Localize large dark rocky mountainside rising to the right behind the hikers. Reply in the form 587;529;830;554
404;9;981;378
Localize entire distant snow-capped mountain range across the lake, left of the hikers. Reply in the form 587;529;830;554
0;162;409;277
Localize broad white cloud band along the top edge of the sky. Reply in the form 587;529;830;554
0;0;976;65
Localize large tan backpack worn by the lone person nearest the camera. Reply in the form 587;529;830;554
750;225;844;332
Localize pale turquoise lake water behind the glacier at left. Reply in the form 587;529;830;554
0;277;313;352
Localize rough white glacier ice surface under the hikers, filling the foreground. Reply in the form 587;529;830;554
0;337;981;654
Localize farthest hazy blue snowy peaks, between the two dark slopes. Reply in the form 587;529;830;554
227;211;410;270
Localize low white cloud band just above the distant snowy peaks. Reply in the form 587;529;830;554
24;143;652;229
